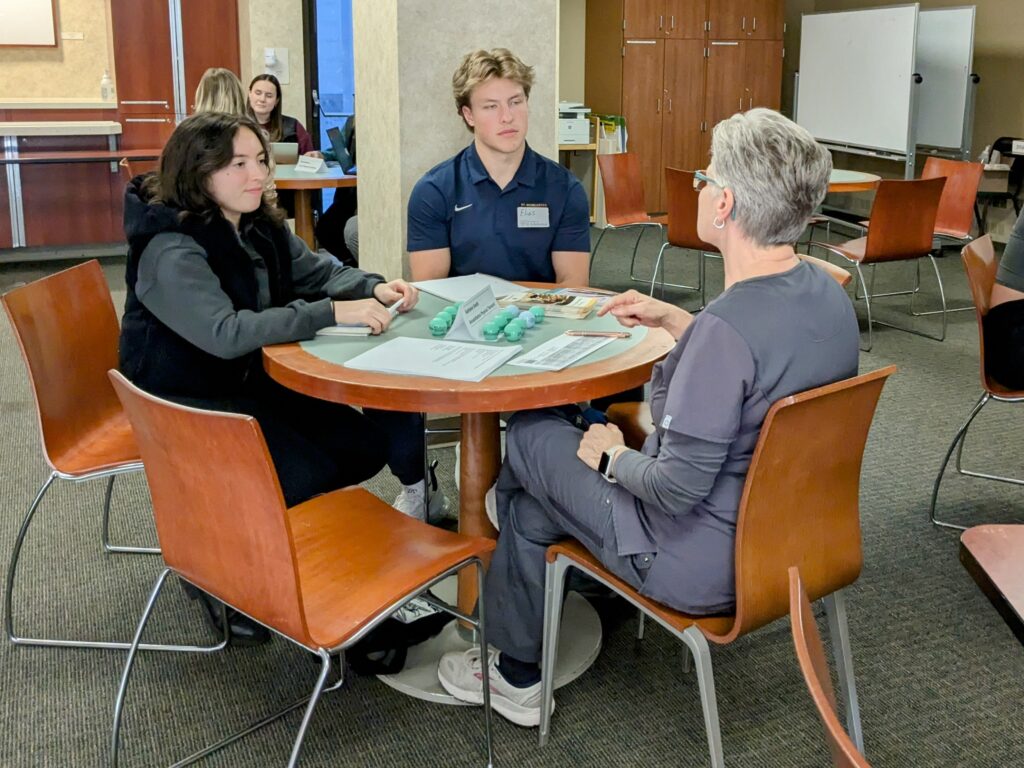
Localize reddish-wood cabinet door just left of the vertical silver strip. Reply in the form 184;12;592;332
111;0;174;115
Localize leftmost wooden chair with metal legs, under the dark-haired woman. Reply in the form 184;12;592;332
2;260;209;650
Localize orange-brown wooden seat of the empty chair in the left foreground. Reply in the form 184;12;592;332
288;488;495;648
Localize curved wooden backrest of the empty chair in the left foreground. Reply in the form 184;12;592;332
110;371;312;645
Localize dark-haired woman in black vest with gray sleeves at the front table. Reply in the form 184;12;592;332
120;113;418;644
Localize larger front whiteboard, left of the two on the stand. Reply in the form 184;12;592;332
797;3;918;154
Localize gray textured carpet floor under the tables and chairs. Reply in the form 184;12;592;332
0;232;1024;767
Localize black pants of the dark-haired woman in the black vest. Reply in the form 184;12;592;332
169;373;387;507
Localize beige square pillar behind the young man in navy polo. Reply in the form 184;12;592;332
352;0;558;276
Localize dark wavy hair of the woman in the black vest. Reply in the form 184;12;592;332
142;112;285;224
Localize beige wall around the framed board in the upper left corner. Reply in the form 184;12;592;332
0;0;114;102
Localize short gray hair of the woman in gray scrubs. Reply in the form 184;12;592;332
711;108;831;246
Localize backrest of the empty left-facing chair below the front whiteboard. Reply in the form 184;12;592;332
864;178;945;263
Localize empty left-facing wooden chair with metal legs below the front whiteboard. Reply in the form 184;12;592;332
813;178;947;352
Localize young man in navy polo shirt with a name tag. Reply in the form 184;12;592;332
373;48;590;519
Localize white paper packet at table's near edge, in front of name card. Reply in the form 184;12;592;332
345;337;522;381
